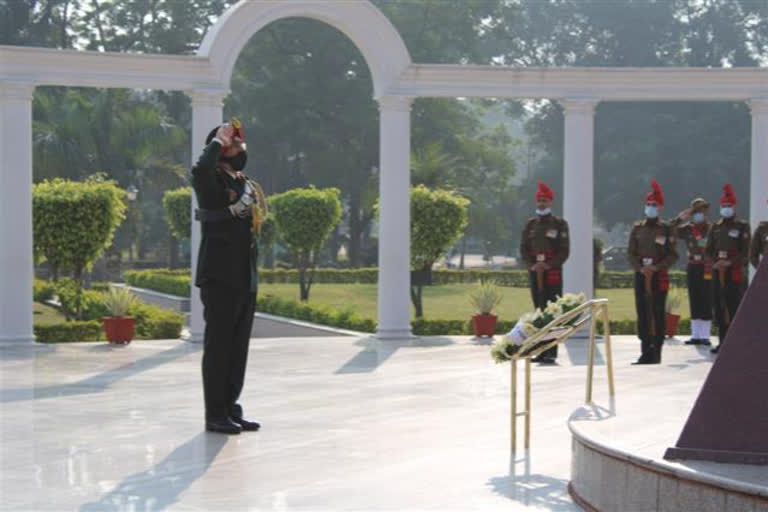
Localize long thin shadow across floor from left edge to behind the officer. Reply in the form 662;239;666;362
0;343;203;402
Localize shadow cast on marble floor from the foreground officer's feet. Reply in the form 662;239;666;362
80;432;229;512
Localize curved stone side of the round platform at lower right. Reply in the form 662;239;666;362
568;421;768;512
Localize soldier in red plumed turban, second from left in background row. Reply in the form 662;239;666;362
627;180;677;364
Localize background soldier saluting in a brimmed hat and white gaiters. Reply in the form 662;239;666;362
673;197;712;345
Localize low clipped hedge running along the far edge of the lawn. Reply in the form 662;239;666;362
123;267;686;290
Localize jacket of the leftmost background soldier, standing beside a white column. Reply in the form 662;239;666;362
520;215;570;268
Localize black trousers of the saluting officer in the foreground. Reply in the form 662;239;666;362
200;282;256;420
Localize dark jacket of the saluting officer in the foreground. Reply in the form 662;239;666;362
192;141;257;291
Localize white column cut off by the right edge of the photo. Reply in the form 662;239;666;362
749;98;768;277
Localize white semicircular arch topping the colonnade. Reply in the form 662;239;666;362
197;0;411;98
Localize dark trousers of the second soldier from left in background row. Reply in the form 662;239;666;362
635;272;667;362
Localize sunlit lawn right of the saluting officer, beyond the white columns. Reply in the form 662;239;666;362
259;284;688;320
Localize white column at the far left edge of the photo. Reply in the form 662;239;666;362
0;82;35;343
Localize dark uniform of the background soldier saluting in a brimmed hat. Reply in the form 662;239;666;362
675;220;712;326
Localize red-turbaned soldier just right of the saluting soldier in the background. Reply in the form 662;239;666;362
706;184;750;354
